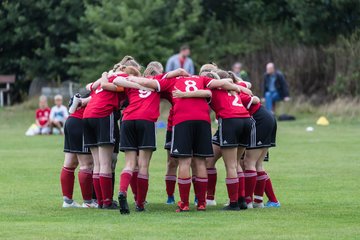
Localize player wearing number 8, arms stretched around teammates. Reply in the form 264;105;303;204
129;71;240;212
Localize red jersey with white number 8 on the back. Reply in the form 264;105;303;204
158;76;212;126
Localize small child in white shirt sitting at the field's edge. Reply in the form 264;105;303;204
50;95;69;134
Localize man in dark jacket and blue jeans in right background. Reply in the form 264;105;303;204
263;62;290;111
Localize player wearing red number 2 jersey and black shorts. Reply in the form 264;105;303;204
176;72;252;211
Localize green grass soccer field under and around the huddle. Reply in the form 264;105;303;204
0;107;360;240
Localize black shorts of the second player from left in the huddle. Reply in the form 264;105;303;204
83;113;118;147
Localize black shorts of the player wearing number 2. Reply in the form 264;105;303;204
212;118;252;148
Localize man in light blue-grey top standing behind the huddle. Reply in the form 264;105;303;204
165;45;195;75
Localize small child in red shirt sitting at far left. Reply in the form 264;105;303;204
35;96;50;135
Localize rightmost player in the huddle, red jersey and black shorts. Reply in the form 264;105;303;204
238;76;280;208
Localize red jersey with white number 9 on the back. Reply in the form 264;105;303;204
123;74;163;122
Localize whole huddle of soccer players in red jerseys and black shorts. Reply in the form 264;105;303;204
60;56;280;214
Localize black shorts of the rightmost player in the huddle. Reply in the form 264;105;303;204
248;106;276;149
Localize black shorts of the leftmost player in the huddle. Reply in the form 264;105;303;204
64;117;90;154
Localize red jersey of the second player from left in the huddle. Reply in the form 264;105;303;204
83;74;128;118
